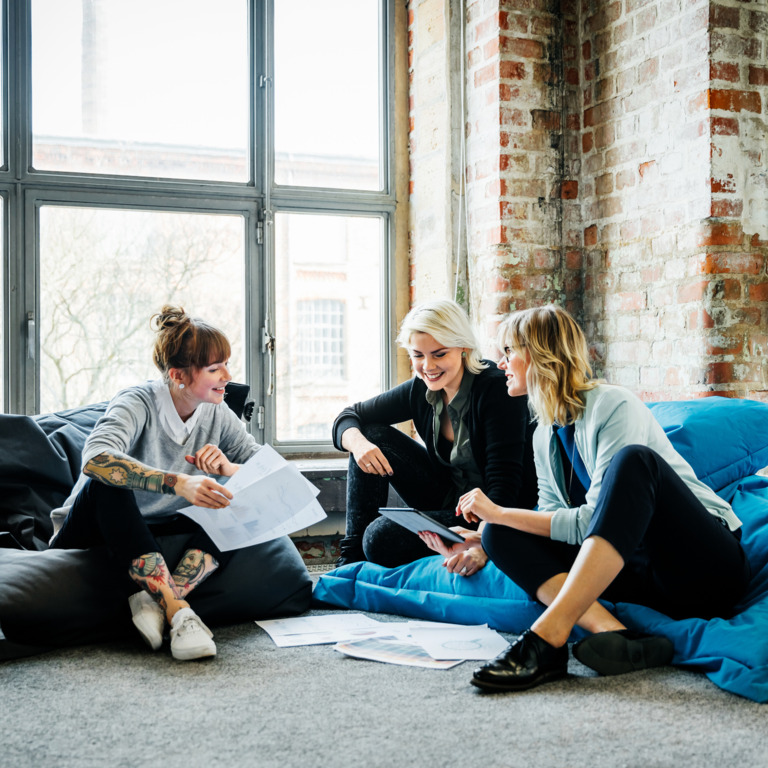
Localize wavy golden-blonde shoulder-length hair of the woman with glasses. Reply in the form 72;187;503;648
498;304;599;426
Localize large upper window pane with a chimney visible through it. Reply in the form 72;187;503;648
32;0;249;181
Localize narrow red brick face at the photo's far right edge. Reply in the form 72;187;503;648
704;0;768;400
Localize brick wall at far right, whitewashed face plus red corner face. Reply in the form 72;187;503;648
582;0;766;399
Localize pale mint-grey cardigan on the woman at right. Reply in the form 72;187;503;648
533;384;741;544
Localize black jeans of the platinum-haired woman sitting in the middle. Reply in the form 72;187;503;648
346;425;476;568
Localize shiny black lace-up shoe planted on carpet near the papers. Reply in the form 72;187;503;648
471;629;568;691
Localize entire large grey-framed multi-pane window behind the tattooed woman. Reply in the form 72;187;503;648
0;0;394;452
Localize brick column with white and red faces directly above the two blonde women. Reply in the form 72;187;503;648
466;0;581;346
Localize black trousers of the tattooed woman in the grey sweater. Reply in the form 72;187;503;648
51;479;231;571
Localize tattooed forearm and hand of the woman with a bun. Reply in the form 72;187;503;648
83;451;232;509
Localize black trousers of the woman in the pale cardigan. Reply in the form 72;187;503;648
483;445;750;618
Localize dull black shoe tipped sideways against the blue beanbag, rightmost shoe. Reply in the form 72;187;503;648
573;629;675;675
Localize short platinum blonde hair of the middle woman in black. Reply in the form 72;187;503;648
397;299;488;373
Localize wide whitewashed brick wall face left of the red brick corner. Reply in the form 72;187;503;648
581;0;710;397
